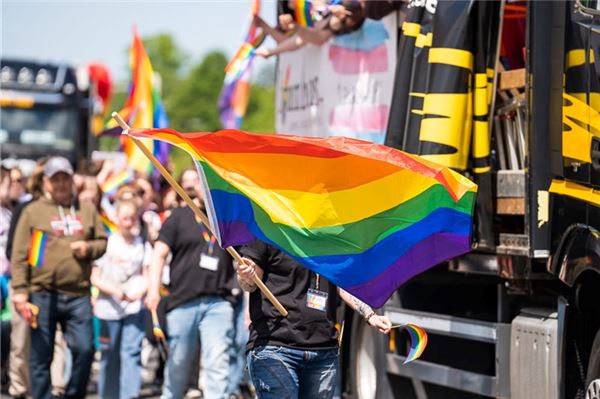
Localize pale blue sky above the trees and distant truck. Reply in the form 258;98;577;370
0;0;276;81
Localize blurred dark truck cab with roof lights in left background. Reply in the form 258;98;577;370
0;59;95;165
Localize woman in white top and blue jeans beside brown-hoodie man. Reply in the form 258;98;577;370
91;201;152;399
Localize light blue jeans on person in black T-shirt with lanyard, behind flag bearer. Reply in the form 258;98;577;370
161;296;233;399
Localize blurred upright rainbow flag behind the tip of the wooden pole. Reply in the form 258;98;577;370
109;29;170;175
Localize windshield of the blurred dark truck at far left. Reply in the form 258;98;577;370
0;107;79;152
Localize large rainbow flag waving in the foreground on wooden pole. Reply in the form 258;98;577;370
130;129;477;307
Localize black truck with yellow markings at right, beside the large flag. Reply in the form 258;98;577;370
318;0;600;399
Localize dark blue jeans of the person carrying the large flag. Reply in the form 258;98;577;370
248;346;339;399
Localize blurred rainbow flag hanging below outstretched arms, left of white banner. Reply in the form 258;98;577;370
219;0;266;129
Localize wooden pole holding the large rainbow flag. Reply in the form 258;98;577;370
112;112;288;317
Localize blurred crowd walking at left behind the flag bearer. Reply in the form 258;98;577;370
0;157;249;398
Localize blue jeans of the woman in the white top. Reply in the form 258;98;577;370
98;312;145;399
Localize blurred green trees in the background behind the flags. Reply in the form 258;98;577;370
106;33;275;176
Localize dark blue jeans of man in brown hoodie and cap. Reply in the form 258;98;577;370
29;292;94;399
